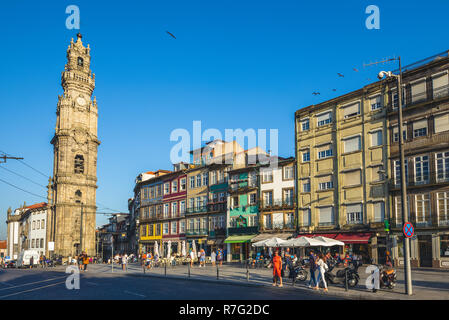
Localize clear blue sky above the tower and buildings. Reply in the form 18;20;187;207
0;0;449;239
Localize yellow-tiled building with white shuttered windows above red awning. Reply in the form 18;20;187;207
295;82;389;261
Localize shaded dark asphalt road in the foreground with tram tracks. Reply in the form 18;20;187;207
0;266;335;300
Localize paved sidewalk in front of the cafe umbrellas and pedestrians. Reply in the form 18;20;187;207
90;264;449;300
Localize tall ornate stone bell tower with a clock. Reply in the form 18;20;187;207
47;33;100;257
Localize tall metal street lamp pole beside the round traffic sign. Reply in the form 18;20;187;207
377;57;413;295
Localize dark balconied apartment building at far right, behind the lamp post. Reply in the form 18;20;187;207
386;52;449;268
